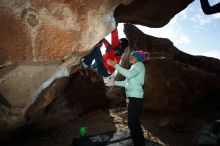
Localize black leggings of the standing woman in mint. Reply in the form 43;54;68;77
128;97;144;146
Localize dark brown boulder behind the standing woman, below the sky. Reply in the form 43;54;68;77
118;24;220;112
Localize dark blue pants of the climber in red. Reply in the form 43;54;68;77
83;47;110;77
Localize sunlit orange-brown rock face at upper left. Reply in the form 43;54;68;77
0;0;127;65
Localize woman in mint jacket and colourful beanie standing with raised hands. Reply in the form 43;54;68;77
108;51;149;146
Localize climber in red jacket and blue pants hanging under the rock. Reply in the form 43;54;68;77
82;28;128;77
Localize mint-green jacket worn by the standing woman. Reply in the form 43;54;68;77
115;61;145;98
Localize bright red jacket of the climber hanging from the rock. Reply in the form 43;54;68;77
103;28;121;73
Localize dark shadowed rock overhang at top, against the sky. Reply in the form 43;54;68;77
115;0;193;27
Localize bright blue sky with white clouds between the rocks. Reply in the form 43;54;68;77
114;0;220;59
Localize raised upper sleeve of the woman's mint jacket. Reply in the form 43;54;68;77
115;64;140;79
